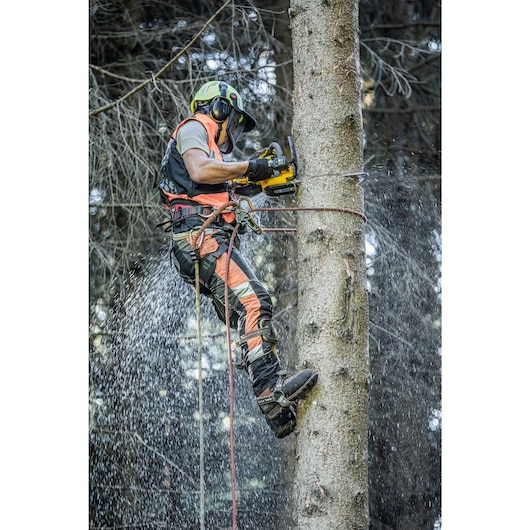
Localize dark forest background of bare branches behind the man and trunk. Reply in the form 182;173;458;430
89;0;441;529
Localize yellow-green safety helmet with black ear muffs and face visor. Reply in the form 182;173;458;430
190;81;256;154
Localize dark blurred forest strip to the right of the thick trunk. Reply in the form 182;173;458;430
359;0;441;529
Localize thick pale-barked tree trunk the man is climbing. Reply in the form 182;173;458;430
290;0;369;530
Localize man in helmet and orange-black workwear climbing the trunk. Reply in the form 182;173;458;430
158;81;318;438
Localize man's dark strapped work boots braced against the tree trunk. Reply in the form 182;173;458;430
258;369;318;438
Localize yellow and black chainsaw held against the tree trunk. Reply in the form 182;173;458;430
230;136;299;197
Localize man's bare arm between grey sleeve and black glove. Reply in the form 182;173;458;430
182;149;248;184
